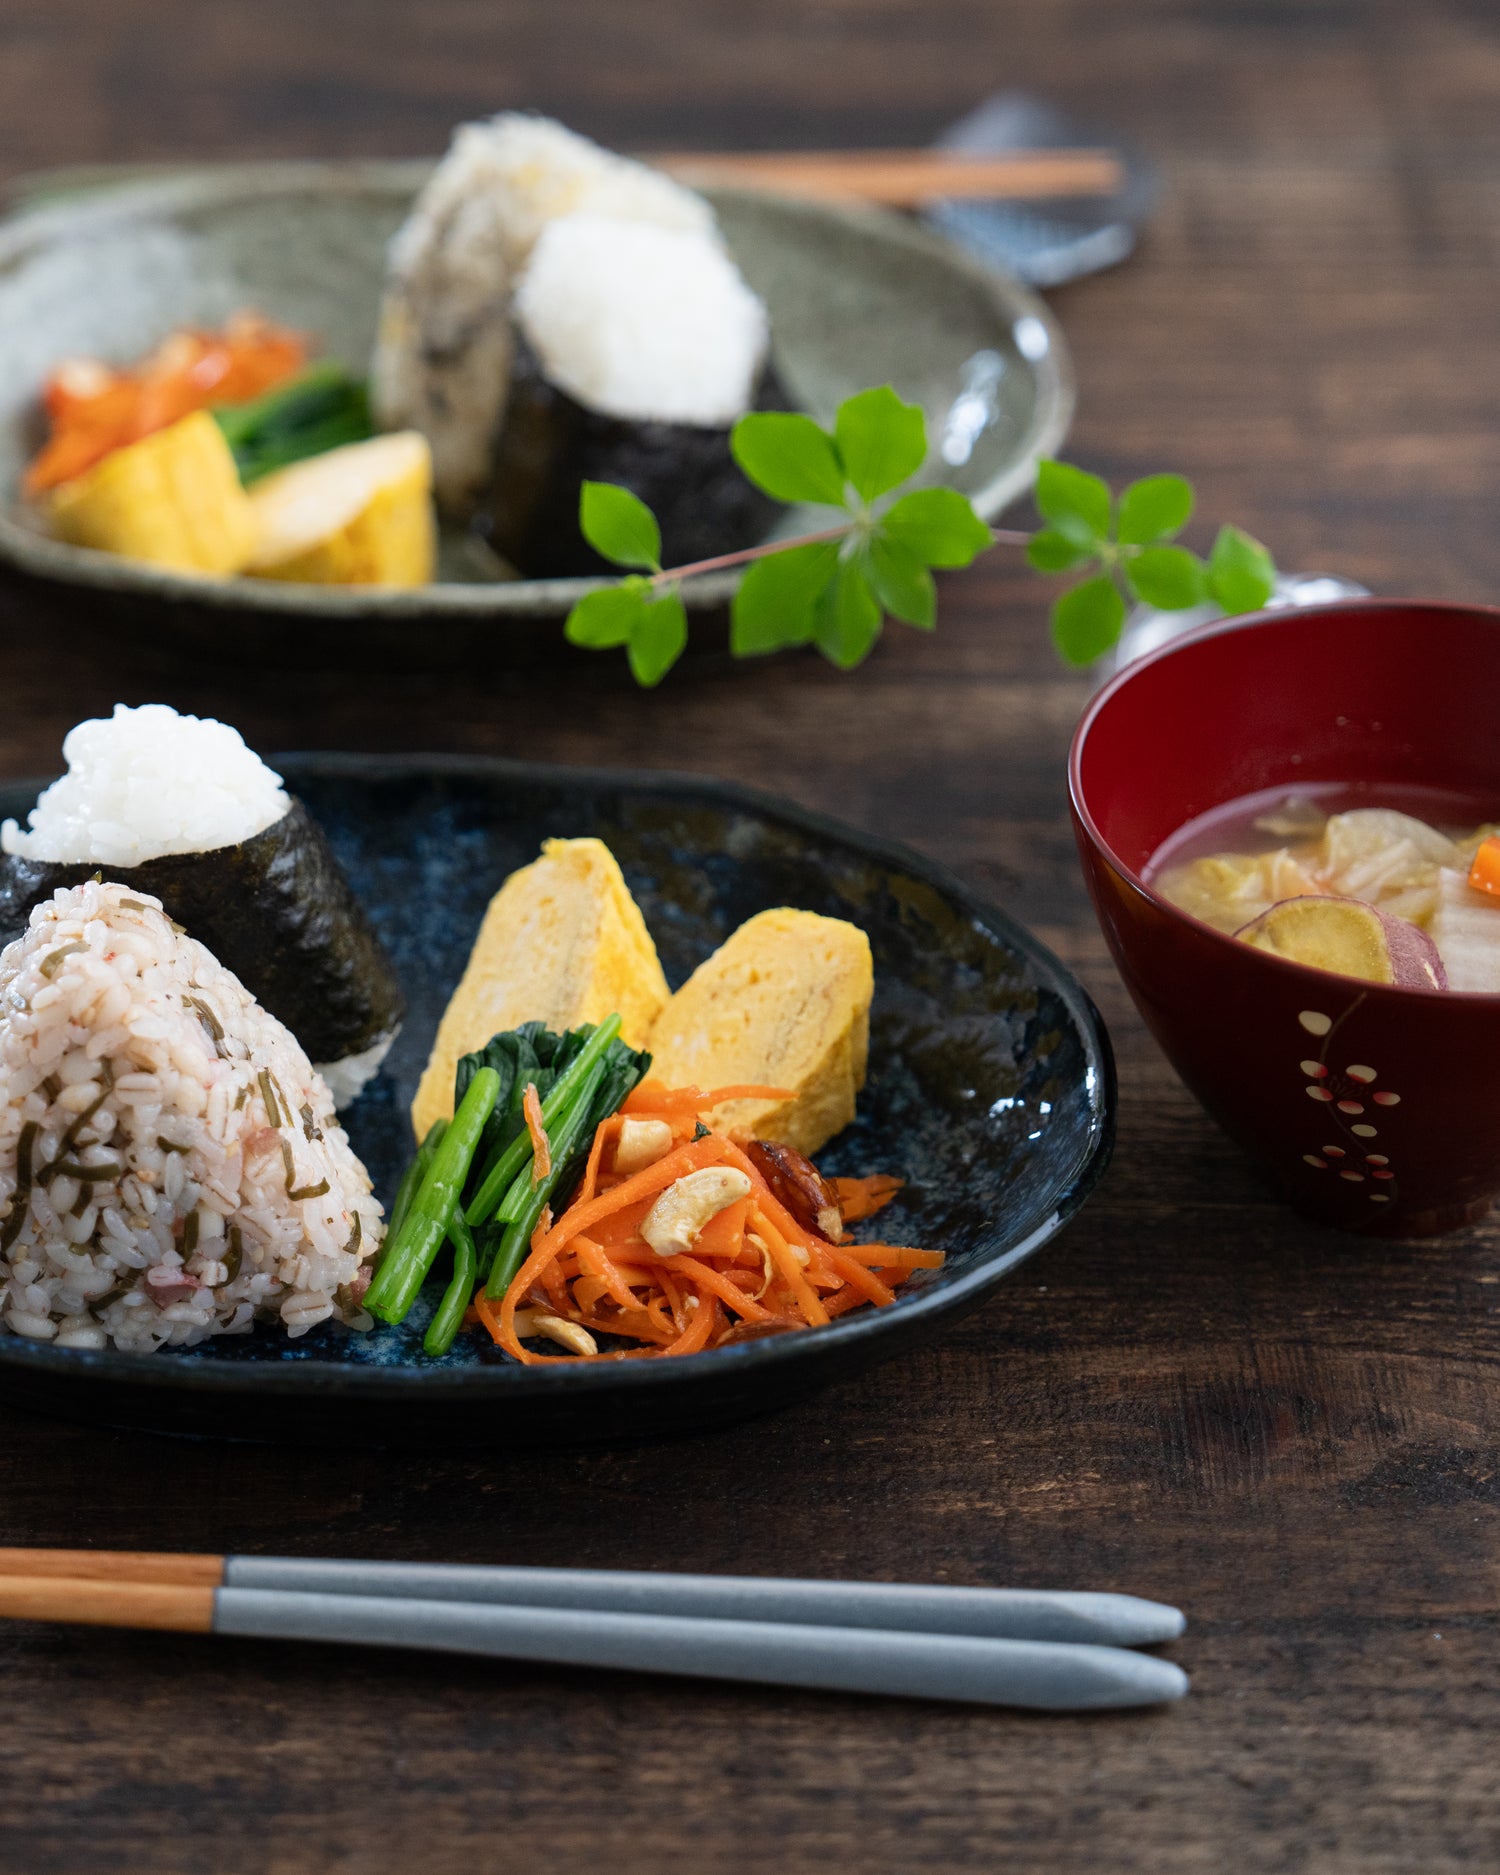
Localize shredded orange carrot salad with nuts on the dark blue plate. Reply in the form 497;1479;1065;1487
473;1080;943;1367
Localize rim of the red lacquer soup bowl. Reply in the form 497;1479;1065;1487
1067;596;1500;1013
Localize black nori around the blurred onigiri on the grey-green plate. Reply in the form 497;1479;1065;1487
474;339;791;579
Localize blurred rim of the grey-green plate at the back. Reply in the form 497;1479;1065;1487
0;158;1078;619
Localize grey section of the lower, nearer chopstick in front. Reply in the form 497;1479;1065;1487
214;1588;1187;1712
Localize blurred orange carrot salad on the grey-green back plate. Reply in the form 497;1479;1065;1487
24;313;308;495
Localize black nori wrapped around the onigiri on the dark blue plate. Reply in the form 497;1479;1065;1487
0;799;405;1104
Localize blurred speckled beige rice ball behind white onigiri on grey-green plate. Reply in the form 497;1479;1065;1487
371;111;716;510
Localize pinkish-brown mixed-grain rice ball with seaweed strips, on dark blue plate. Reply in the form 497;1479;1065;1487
0;881;381;1352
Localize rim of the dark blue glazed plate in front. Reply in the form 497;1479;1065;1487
0;750;1118;1403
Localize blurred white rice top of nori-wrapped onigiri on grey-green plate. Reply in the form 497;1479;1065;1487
516;214;769;429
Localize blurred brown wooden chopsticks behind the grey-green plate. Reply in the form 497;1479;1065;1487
649;150;1125;208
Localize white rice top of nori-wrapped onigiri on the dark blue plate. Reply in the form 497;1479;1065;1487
0;703;291;866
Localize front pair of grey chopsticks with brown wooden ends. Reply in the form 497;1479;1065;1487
0;1549;1187;1712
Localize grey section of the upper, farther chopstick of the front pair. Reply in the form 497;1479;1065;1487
225;1556;1187;1646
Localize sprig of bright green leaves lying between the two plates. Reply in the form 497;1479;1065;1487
566;384;1275;686
